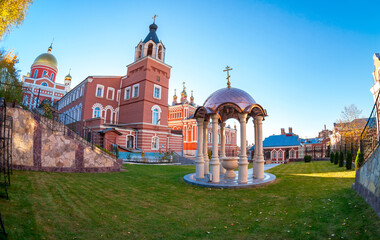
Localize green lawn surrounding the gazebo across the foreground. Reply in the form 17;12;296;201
0;162;380;239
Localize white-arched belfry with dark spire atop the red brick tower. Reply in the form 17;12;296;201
135;17;165;62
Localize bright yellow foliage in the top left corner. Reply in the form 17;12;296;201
0;0;33;40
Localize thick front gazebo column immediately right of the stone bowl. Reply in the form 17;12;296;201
238;113;248;183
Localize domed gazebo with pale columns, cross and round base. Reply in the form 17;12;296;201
185;66;276;188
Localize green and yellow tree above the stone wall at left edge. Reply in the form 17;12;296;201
0;51;22;103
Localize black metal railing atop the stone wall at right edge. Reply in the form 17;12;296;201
360;92;380;161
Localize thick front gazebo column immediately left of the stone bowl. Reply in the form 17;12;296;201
210;114;220;183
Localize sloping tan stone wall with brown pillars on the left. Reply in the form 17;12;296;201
7;108;121;172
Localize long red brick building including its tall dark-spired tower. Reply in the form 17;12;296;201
57;23;182;157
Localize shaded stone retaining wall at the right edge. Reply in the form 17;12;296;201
353;144;380;217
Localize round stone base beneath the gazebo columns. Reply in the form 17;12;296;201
183;171;276;189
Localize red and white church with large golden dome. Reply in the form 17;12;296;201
22;45;71;108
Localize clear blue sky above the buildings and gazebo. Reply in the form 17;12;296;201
0;0;380;143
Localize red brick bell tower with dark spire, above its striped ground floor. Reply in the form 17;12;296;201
119;19;171;132
